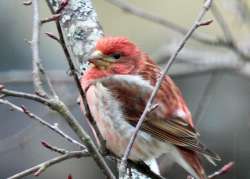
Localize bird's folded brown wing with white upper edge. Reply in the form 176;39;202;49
98;75;218;159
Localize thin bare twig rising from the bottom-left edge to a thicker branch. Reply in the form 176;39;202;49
7;151;89;179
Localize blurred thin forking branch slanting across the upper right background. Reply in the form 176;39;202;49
106;0;250;64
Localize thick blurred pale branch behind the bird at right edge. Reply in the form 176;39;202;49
158;43;250;78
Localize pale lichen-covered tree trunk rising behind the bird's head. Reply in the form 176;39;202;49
49;0;103;68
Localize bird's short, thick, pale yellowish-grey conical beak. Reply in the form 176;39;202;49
88;50;110;69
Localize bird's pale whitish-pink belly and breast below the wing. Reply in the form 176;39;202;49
87;83;174;161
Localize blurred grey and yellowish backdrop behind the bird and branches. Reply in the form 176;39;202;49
0;0;250;179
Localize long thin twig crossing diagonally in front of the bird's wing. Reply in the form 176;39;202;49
119;0;212;177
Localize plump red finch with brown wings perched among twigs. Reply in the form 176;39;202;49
80;36;221;179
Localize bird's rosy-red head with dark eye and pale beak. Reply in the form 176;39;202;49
89;37;141;76
